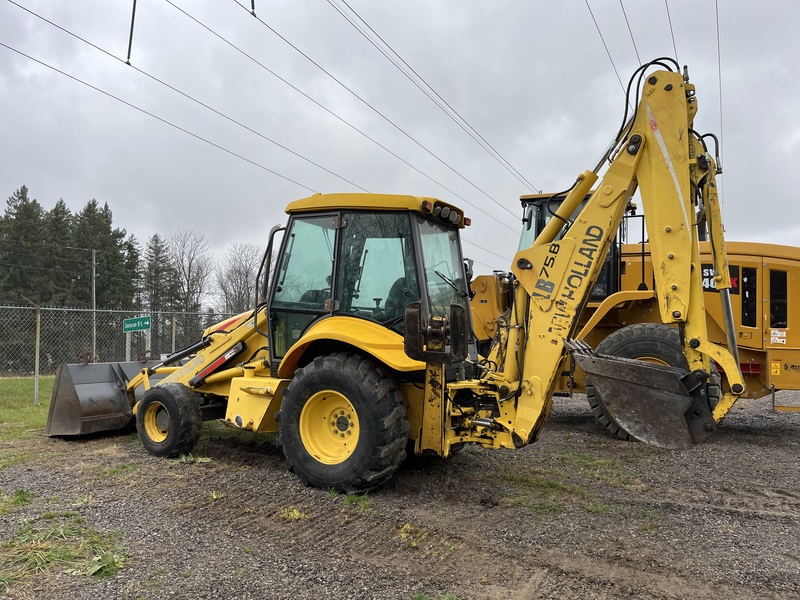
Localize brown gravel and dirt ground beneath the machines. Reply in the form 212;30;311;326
0;394;800;600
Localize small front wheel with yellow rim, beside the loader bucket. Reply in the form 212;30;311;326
136;383;203;457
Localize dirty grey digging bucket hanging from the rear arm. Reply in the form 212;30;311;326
566;341;717;449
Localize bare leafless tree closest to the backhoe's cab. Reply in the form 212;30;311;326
216;242;261;313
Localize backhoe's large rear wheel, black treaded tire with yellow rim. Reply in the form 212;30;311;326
276;353;409;492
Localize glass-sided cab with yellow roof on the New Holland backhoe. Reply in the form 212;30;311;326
269;194;469;366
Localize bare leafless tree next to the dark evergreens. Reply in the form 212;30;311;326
167;229;214;312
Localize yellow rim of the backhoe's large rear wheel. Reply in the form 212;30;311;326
300;390;360;465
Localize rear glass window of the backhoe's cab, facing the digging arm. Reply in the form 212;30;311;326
417;218;469;317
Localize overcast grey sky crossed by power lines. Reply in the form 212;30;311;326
0;0;800;272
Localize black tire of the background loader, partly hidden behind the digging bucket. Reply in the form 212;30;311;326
586;323;689;441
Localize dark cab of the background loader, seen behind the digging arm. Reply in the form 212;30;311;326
518;192;635;301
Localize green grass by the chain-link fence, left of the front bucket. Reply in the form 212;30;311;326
0;376;55;442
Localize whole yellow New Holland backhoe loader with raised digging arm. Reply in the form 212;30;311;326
42;59;744;491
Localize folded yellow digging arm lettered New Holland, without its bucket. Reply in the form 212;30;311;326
498;71;744;445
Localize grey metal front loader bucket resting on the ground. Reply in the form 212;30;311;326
45;361;157;436
